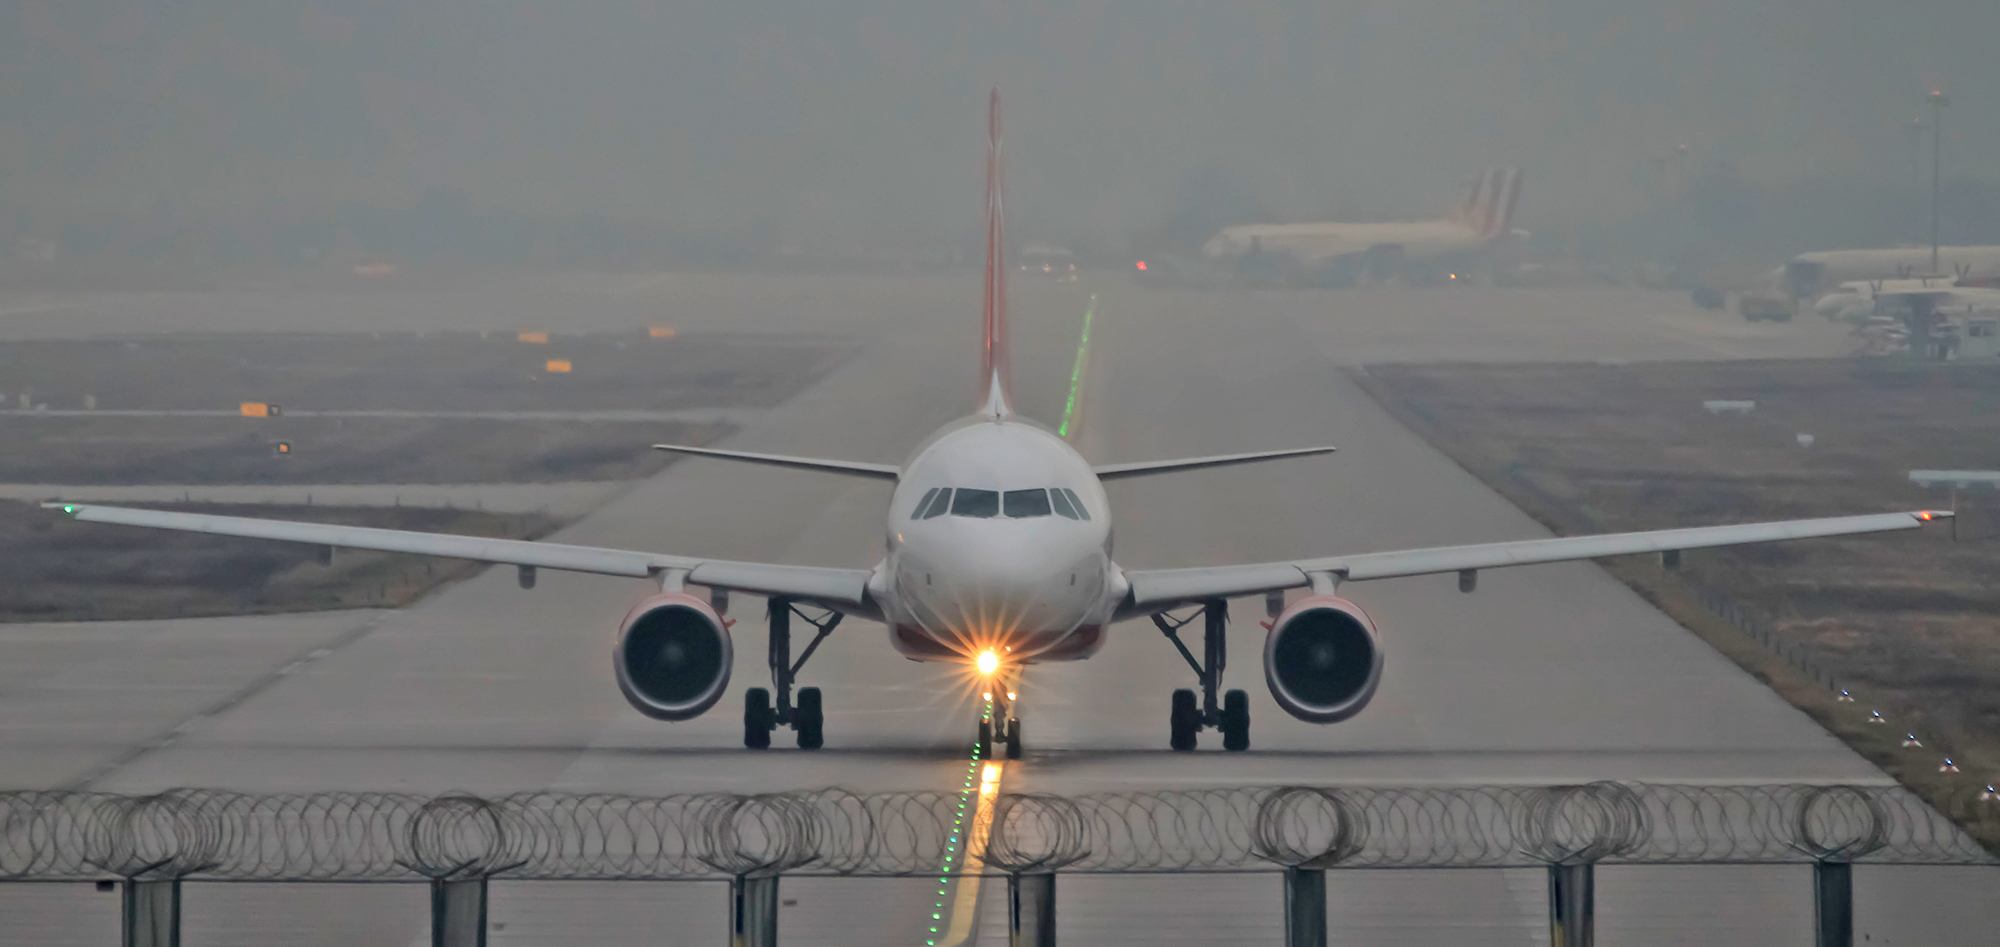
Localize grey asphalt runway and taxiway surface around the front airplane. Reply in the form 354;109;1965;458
0;274;2000;947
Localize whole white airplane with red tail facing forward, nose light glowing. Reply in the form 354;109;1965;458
46;94;1950;757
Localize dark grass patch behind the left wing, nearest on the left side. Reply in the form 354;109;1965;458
0;503;562;621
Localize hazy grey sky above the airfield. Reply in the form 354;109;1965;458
0;0;2000;246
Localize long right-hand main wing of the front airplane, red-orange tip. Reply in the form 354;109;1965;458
1120;509;1952;615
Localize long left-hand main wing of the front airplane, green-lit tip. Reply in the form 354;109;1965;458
42;503;876;615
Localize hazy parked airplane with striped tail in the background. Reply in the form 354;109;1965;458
1202;168;1520;279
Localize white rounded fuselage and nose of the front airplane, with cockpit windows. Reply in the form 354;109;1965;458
870;418;1124;663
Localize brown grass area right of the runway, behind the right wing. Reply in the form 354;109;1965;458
1358;360;2000;845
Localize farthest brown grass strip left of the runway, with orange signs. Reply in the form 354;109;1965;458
0;332;852;412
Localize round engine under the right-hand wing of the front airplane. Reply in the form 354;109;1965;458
1264;595;1382;723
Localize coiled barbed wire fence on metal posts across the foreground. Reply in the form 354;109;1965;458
0;783;2000;943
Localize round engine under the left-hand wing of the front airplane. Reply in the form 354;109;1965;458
612;593;736;719
